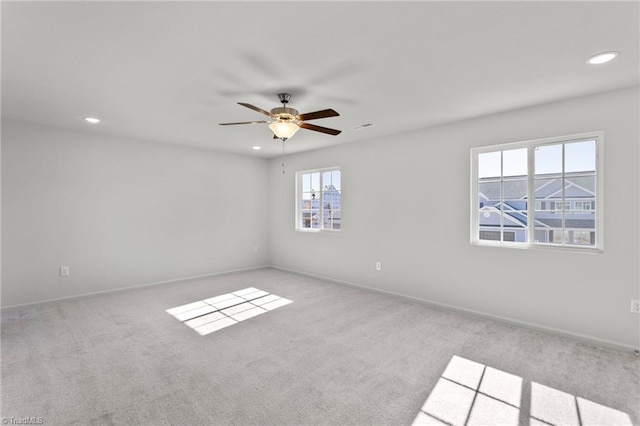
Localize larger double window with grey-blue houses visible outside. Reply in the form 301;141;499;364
471;133;602;250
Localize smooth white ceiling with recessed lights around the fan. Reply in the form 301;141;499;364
1;1;640;157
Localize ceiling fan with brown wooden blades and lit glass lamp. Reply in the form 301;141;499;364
220;93;342;141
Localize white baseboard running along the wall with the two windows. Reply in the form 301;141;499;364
271;265;640;355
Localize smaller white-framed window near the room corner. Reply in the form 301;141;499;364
296;168;342;231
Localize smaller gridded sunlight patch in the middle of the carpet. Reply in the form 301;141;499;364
167;287;292;336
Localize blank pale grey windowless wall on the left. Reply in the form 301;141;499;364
2;121;268;307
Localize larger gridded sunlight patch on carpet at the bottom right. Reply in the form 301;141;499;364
413;355;632;426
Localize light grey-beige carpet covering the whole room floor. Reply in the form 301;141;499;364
1;269;640;425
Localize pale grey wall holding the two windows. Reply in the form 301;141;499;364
269;87;640;348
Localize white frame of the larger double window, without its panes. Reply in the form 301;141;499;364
470;131;604;253
